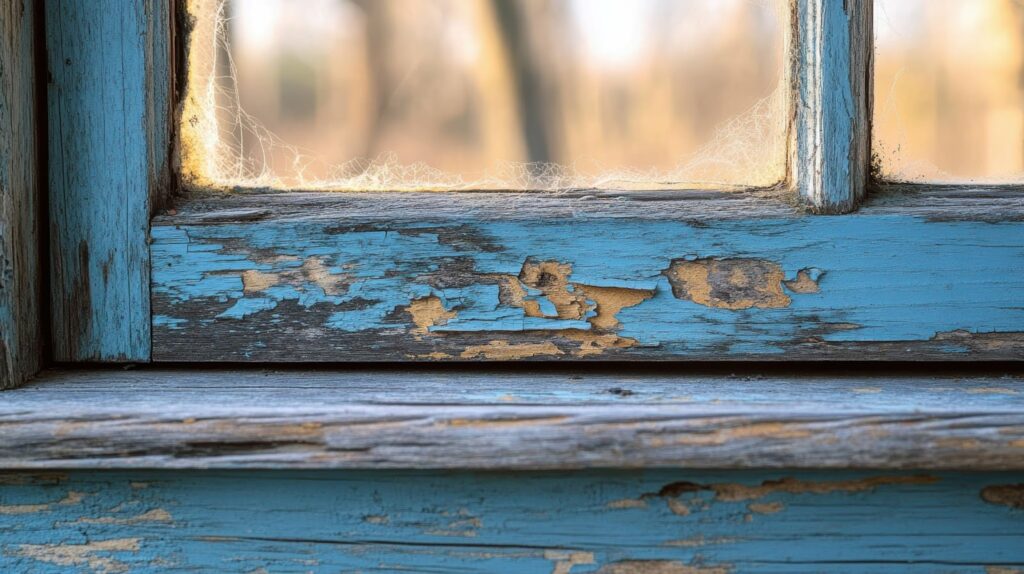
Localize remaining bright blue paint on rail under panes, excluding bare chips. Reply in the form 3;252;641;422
153;215;1024;358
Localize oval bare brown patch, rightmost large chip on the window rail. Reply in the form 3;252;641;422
665;259;792;310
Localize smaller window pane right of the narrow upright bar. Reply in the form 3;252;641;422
873;0;1024;183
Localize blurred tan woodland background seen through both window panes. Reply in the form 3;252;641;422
208;0;1024;189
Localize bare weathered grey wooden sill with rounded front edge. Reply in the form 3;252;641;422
0;369;1024;471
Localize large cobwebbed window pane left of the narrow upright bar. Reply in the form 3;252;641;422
182;0;790;189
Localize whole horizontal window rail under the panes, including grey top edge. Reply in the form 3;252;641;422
152;190;1024;362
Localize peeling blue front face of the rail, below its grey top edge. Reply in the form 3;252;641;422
152;215;1024;361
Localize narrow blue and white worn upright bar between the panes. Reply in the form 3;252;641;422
790;0;874;214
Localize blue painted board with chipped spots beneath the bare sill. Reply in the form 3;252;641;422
0;471;1024;574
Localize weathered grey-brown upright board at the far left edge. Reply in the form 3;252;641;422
0;0;42;390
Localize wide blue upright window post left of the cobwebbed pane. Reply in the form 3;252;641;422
46;0;171;362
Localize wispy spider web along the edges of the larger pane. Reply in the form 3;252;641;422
180;0;792;191
